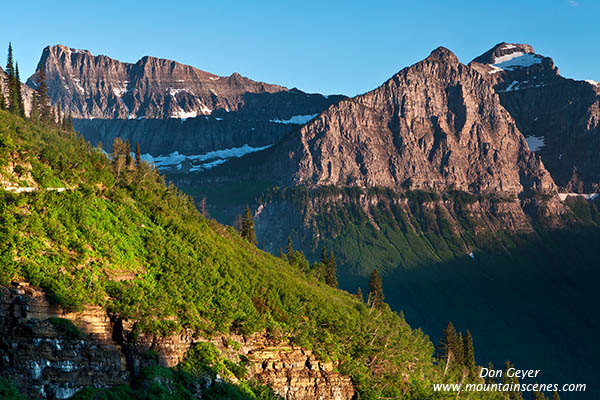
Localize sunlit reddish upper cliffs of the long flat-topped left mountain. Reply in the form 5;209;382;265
27;45;296;119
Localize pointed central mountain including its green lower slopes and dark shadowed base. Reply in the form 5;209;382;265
186;44;600;398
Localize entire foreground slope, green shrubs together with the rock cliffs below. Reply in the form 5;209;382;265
0;111;524;399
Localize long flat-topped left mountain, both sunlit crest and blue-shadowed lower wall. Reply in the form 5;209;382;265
27;45;343;163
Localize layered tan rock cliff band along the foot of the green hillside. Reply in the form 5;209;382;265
0;283;354;400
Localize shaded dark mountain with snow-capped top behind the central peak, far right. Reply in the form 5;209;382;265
469;43;600;193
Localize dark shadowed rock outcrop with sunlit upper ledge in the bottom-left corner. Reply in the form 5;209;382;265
0;284;129;399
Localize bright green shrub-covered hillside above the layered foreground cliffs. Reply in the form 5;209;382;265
0;111;520;398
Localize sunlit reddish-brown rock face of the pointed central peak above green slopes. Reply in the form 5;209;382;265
251;48;556;194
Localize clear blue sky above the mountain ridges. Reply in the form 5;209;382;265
0;0;600;95
